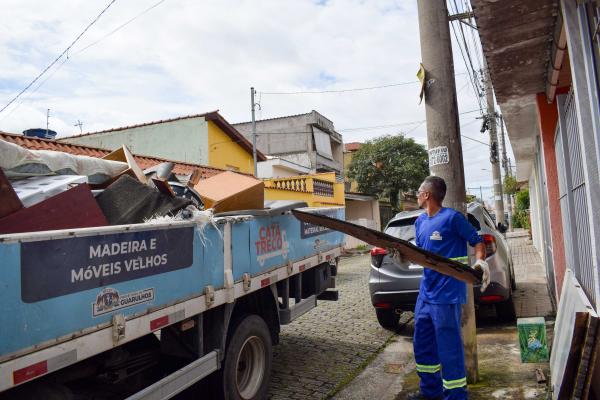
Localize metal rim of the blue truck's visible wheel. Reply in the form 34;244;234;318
236;336;266;399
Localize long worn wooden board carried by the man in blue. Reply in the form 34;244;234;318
292;210;481;284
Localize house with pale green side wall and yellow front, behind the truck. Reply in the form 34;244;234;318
60;111;266;174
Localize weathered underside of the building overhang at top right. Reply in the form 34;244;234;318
471;0;559;180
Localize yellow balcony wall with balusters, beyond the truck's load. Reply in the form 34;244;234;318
264;172;345;207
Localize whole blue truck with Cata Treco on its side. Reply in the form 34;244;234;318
0;204;344;400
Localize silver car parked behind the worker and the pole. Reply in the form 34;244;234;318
369;203;516;329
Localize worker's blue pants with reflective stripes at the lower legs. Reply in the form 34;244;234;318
413;296;467;400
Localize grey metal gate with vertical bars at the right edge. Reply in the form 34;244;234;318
555;89;596;304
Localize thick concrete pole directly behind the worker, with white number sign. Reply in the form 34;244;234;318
417;0;478;383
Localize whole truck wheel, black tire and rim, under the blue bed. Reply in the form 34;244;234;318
221;315;273;400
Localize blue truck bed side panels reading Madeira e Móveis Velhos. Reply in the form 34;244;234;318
0;208;344;391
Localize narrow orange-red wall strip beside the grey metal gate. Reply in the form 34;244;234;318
536;93;566;299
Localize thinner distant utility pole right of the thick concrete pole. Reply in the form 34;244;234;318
483;59;504;224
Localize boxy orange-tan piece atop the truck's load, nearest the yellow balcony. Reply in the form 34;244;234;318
194;171;265;213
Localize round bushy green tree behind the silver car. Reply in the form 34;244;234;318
348;134;429;210
